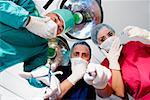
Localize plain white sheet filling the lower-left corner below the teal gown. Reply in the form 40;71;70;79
0;63;45;100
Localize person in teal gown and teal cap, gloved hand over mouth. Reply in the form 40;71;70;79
0;0;74;72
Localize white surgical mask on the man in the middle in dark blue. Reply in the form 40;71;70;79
71;57;88;66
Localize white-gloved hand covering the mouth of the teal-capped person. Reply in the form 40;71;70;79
25;16;57;38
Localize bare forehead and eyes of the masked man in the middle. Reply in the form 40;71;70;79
71;44;90;62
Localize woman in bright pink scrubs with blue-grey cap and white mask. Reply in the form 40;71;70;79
91;24;150;100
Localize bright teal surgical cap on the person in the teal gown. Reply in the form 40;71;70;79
52;9;75;33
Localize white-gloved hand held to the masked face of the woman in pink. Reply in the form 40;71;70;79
101;37;122;70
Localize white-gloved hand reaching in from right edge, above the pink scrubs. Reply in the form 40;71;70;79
123;26;150;40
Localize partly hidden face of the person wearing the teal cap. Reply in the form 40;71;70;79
46;13;64;35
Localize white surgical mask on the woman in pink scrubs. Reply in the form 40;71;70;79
99;36;118;52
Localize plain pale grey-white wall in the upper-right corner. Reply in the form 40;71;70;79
102;0;150;32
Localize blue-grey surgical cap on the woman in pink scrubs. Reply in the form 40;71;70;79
91;24;115;44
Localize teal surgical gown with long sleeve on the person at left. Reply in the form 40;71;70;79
0;0;48;72
